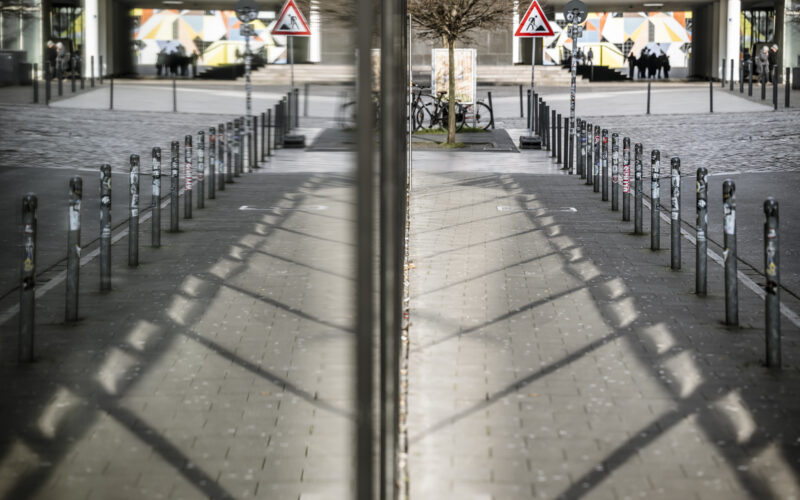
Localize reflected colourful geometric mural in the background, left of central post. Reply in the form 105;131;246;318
131;9;286;66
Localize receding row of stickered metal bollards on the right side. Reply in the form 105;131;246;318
531;105;781;369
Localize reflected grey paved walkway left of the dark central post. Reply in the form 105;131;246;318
0;151;354;500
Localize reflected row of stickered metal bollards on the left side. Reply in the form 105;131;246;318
18;100;290;362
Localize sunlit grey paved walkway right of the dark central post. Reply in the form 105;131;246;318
408;152;800;499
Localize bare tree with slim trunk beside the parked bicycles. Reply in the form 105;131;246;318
408;0;511;144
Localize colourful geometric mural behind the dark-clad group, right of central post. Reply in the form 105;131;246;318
544;12;692;68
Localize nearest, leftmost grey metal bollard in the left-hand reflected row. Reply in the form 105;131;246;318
18;193;38;362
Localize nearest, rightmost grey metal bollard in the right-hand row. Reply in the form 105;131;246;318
764;197;781;370
